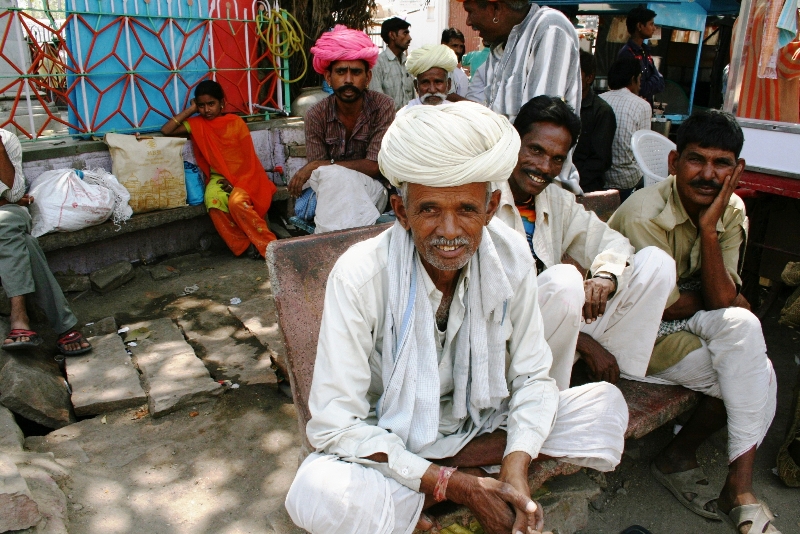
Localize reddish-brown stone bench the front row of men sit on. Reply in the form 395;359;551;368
267;191;699;526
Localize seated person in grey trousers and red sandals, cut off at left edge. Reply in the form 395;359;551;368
0;128;92;356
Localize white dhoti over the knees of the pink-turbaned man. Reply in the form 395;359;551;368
305;165;389;234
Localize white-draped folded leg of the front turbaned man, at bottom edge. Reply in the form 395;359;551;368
286;453;425;534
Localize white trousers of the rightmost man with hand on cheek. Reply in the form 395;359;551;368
625;308;778;462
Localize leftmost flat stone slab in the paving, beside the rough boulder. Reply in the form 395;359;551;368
66;333;147;416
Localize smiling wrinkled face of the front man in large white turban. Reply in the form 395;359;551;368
392;183;500;271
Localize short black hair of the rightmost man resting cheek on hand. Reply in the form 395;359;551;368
676;109;744;159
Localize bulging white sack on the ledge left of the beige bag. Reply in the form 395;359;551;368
28;169;132;237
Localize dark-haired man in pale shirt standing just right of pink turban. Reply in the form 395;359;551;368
369;17;414;111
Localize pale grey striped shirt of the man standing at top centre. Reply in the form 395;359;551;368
484;4;581;122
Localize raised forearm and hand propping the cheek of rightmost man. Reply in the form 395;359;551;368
698;166;744;310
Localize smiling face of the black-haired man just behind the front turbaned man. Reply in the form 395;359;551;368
510;122;572;197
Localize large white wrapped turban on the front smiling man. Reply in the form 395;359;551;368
378;101;520;187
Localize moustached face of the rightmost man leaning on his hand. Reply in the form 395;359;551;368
669;143;744;217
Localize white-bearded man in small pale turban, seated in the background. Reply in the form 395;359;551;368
406;44;458;107
